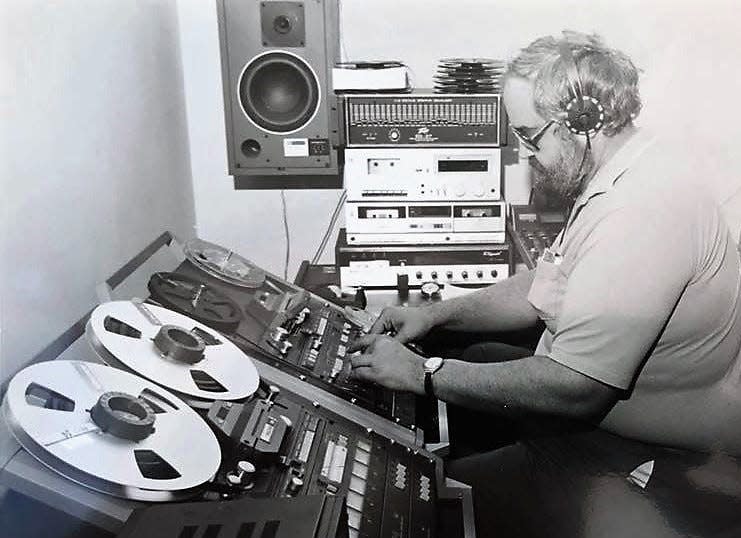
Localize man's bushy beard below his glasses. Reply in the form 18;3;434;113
529;138;594;209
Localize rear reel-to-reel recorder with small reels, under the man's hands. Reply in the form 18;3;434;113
161;239;419;430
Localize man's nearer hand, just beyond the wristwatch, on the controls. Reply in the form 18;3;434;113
349;334;425;395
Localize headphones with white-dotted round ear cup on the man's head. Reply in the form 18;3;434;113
559;41;605;138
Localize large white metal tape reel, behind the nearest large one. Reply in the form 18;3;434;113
87;301;260;407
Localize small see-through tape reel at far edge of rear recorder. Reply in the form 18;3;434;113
183;238;265;288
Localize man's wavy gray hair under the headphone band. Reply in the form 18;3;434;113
505;32;641;136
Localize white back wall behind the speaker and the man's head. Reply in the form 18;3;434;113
178;0;741;275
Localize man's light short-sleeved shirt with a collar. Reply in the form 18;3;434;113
528;131;741;455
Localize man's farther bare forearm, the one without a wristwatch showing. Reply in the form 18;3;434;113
426;270;538;332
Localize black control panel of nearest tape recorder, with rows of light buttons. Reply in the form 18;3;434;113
207;385;440;538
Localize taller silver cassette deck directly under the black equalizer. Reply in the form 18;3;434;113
344;147;502;201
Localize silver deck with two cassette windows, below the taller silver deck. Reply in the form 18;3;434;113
345;202;507;244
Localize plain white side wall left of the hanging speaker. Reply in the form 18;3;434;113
0;0;195;381
